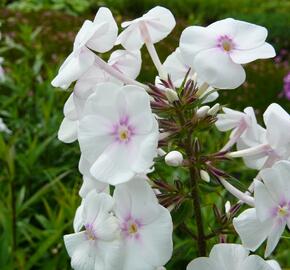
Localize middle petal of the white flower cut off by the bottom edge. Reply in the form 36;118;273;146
209;244;249;270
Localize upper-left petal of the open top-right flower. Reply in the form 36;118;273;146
179;26;216;68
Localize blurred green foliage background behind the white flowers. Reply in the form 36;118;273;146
0;0;290;270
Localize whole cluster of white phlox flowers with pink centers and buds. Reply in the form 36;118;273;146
52;6;290;270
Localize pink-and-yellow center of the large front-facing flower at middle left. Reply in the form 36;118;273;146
112;116;134;144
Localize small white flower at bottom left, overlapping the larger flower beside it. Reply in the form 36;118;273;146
64;191;120;270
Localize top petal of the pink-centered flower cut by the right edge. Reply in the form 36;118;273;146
260;160;290;206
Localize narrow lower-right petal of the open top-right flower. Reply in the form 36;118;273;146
230;43;276;64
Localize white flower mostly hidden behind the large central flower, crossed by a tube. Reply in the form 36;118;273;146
58;50;141;143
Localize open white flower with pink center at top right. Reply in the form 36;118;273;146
180;18;275;89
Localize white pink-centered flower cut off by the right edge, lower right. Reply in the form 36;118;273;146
233;161;290;257
